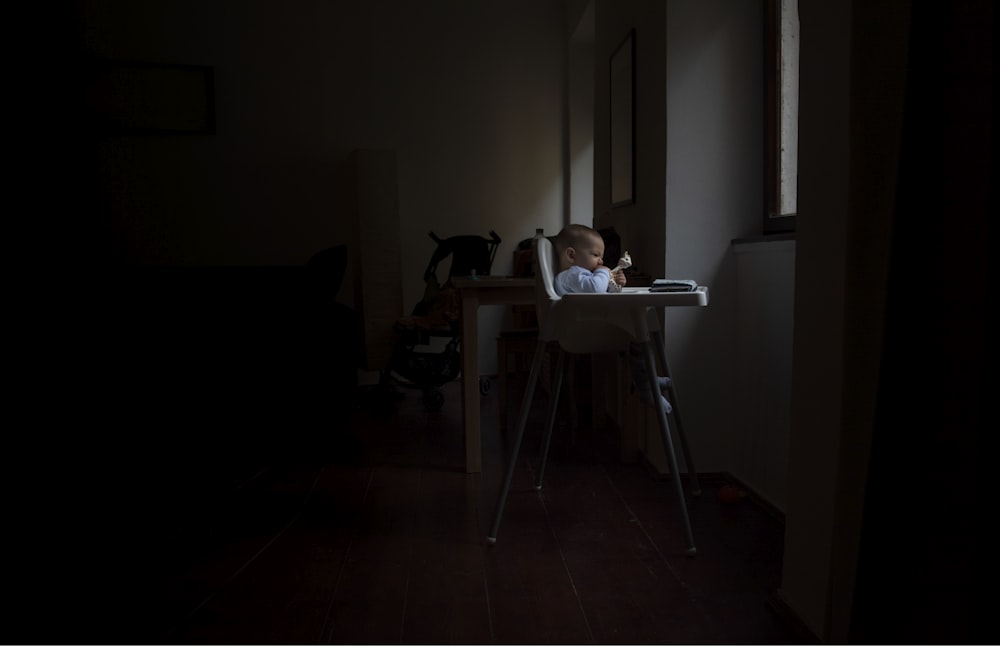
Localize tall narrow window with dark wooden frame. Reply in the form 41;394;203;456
764;0;799;233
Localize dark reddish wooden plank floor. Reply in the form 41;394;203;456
9;382;802;644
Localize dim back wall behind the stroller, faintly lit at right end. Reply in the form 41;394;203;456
82;0;566;373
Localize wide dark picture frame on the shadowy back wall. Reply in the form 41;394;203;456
83;60;215;135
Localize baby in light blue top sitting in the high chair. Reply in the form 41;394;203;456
553;224;673;413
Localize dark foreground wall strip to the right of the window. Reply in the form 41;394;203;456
778;0;916;643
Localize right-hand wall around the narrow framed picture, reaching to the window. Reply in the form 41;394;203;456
594;0;763;471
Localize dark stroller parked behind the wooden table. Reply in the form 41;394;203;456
385;231;500;411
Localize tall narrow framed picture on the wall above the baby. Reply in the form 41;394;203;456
610;29;635;207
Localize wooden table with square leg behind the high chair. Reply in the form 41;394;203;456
451;276;535;473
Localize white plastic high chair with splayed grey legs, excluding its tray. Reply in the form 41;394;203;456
486;237;701;556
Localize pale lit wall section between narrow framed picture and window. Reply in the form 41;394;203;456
663;0;763;472
